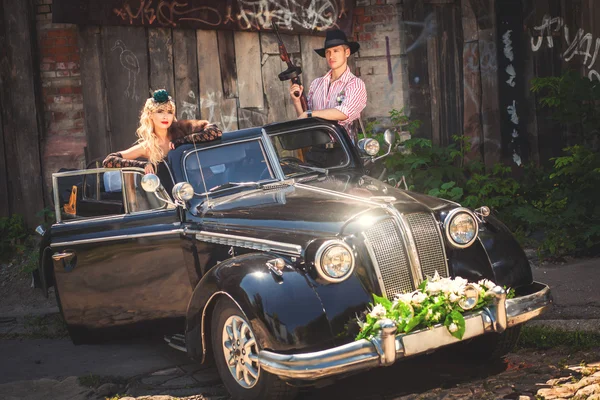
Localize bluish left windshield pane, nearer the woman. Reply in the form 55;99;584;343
184;139;274;194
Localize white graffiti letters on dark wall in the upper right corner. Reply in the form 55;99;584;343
531;15;600;81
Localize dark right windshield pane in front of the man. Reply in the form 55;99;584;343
271;128;350;177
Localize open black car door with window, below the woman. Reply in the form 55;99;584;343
51;169;192;343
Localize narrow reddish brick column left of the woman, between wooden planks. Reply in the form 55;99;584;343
36;0;86;197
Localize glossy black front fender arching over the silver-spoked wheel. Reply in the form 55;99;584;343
185;253;333;362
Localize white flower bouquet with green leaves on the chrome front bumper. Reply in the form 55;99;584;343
356;271;514;340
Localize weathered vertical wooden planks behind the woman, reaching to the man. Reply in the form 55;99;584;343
79;26;327;158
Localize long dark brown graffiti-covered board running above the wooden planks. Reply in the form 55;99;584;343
52;0;354;33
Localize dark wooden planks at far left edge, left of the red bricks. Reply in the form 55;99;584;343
0;0;44;227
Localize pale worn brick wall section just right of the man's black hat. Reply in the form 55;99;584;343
353;0;408;126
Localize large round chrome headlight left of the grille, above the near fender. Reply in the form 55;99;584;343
315;240;354;283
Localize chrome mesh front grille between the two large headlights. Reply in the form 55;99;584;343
364;213;448;300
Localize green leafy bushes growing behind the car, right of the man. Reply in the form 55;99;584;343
358;104;600;257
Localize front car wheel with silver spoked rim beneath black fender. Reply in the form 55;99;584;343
211;298;297;400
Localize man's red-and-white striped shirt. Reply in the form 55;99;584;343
306;68;367;141
